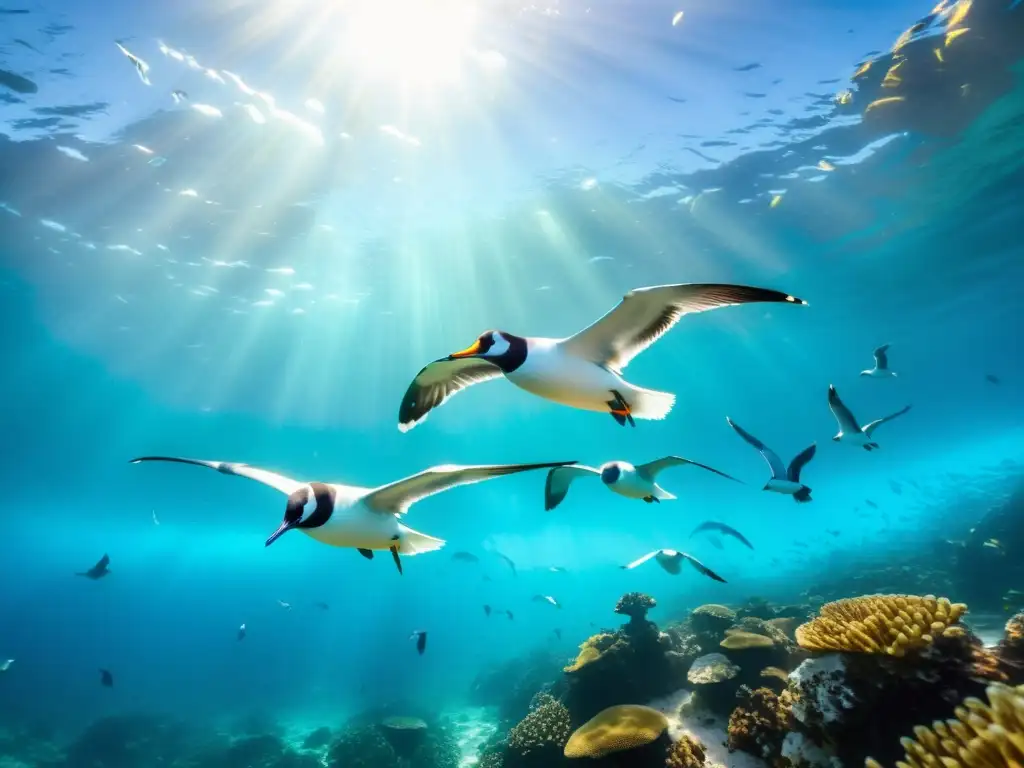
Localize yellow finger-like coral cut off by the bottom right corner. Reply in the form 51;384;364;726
864;685;1024;768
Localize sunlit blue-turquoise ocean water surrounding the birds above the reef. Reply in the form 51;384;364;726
0;0;1024;768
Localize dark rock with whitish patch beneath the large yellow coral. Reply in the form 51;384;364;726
790;631;1002;766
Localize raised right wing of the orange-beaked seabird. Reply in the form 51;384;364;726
562;283;807;372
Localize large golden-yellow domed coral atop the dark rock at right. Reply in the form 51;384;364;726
797;595;967;656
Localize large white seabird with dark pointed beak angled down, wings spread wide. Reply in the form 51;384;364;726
131;456;572;573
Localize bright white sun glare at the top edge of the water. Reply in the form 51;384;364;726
342;0;476;84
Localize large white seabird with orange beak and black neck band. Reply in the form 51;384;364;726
398;284;807;432
